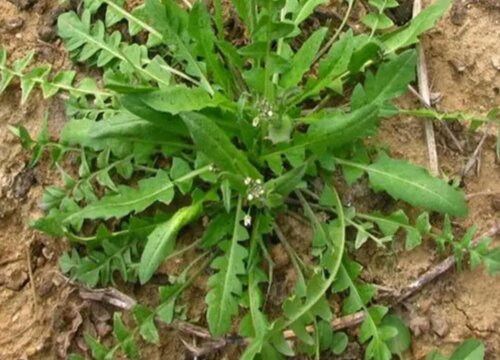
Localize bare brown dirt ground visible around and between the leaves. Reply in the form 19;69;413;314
0;0;500;359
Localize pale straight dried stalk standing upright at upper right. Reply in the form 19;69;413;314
413;0;439;175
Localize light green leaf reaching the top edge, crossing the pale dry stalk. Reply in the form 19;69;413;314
382;0;451;54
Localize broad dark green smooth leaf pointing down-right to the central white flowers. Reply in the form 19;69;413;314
182;113;262;179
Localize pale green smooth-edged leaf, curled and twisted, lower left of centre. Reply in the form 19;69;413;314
139;201;203;284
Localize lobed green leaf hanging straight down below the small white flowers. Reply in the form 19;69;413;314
205;197;248;336
